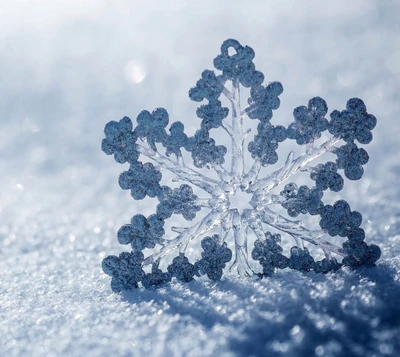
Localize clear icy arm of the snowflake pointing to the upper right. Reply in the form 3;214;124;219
247;137;340;193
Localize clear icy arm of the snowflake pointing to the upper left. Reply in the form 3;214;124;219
136;144;218;194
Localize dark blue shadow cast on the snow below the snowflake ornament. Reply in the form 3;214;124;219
123;264;400;357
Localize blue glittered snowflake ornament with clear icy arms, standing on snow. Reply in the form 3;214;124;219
102;39;381;292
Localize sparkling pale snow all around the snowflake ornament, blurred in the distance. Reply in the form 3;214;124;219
0;0;400;357
